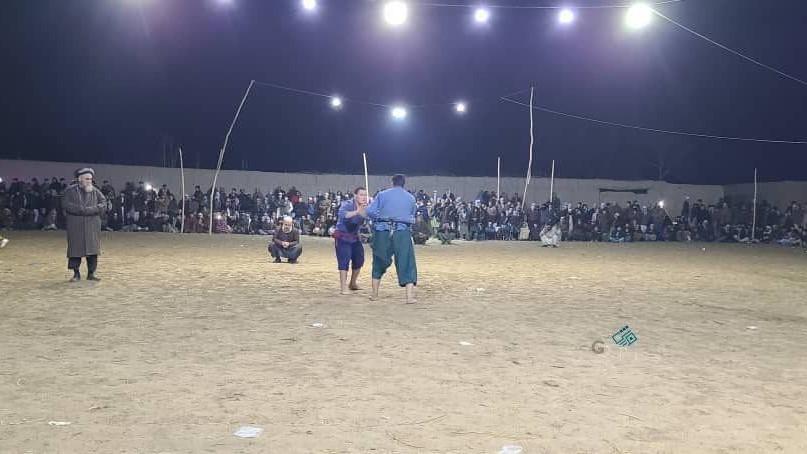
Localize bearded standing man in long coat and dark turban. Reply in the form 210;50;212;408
62;167;106;282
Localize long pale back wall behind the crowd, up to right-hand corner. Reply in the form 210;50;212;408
0;160;732;215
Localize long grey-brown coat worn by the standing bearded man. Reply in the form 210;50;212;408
62;185;106;257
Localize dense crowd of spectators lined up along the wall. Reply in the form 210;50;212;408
0;177;805;246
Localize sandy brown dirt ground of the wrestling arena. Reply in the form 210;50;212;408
0;232;807;454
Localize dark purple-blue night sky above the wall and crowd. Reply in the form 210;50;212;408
0;0;807;184
